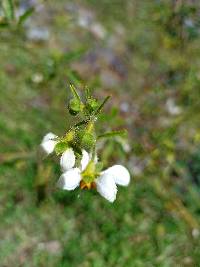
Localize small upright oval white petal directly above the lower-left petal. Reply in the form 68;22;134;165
60;148;76;172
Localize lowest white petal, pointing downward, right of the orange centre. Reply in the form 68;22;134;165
96;173;117;202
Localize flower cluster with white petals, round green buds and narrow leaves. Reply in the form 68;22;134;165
41;86;130;202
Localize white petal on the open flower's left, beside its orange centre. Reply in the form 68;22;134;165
57;168;81;190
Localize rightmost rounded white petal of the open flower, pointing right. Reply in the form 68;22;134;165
103;165;130;186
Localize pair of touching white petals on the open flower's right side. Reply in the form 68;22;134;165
96;165;130;202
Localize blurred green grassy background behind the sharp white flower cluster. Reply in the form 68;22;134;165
0;0;200;267
